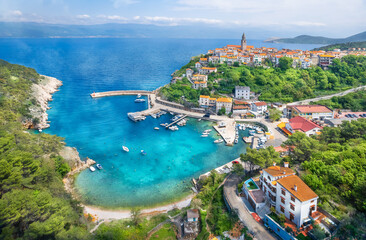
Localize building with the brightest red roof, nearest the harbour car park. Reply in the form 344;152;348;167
285;116;323;136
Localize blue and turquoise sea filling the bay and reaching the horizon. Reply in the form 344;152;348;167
0;39;319;208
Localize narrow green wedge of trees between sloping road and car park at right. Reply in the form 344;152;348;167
314;90;366;112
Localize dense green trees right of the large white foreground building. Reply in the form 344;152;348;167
284;119;366;239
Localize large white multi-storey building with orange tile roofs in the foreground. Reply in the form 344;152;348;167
260;163;318;227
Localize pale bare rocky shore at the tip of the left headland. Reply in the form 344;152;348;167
29;75;62;129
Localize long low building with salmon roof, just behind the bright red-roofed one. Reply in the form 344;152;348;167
284;105;334;120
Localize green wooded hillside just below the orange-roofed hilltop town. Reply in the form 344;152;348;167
160;55;366;103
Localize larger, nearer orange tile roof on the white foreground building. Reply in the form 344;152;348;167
277;175;318;202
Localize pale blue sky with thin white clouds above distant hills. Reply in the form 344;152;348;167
0;0;366;37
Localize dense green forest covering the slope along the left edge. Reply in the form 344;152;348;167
0;60;89;239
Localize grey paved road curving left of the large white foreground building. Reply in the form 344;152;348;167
224;175;277;240
